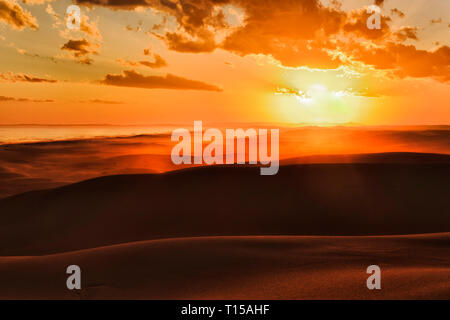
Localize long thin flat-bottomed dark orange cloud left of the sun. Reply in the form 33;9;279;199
100;70;222;91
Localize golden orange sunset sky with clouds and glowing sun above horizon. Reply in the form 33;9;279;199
0;0;450;125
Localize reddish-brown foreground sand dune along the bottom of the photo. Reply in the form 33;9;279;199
0;233;450;299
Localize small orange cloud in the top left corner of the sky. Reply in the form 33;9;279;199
0;0;39;30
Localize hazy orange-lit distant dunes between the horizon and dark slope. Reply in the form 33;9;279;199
0;123;450;198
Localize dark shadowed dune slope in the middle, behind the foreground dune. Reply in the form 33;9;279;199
0;152;450;255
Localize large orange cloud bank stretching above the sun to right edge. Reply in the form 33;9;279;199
77;0;450;82
